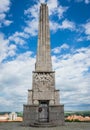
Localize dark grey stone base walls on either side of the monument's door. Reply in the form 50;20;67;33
23;105;64;126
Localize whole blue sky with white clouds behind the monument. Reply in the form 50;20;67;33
0;0;90;111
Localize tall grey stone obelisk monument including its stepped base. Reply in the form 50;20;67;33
23;4;64;125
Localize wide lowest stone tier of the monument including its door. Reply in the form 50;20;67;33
23;105;64;127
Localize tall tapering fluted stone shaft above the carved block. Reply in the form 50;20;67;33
36;4;52;71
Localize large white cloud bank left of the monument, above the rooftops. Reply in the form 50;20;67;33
0;52;35;111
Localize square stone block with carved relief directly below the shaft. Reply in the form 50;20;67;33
33;72;55;91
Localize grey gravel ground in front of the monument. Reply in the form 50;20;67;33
0;122;90;130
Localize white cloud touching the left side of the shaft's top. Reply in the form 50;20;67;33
24;4;39;36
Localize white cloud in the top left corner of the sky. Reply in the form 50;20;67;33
0;0;12;27
